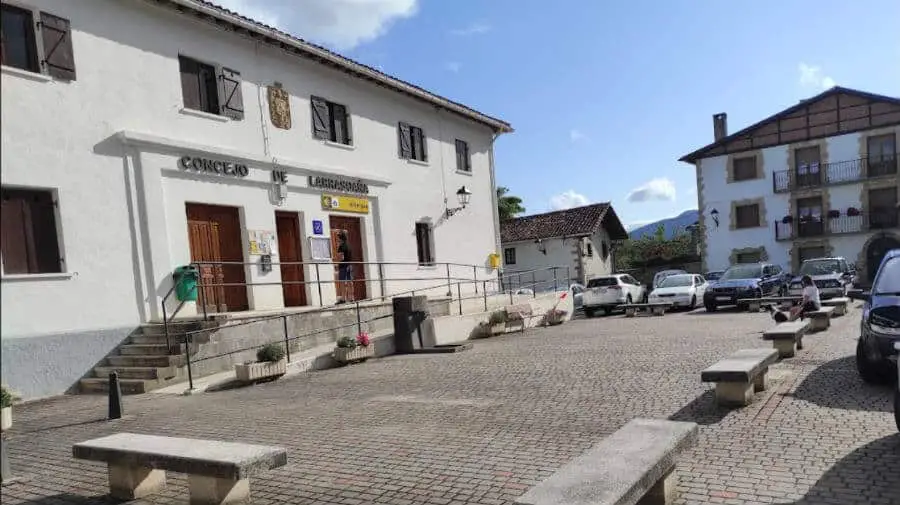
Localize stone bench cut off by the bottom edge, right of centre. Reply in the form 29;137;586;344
515;419;697;505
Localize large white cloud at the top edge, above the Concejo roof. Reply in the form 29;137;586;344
214;0;418;50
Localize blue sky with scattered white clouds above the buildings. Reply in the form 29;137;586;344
214;0;900;228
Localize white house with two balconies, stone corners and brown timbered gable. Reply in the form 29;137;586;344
680;87;900;282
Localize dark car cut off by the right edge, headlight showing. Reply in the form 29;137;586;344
848;249;900;383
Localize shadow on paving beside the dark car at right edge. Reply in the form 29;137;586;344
792;356;894;412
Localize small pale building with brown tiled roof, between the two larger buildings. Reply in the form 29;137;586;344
500;203;628;291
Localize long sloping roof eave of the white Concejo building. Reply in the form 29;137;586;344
150;0;515;134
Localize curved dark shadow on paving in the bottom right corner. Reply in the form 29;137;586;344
780;434;900;505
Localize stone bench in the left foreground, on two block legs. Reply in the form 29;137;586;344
72;433;287;505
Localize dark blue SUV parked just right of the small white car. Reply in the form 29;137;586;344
703;263;789;312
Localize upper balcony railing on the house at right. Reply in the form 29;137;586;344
772;154;900;193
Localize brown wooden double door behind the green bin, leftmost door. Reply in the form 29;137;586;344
186;203;250;312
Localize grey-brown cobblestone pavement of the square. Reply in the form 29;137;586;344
3;308;900;505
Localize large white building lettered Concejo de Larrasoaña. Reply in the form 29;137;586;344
0;0;512;395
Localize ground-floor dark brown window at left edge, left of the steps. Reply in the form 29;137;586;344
0;188;62;274
